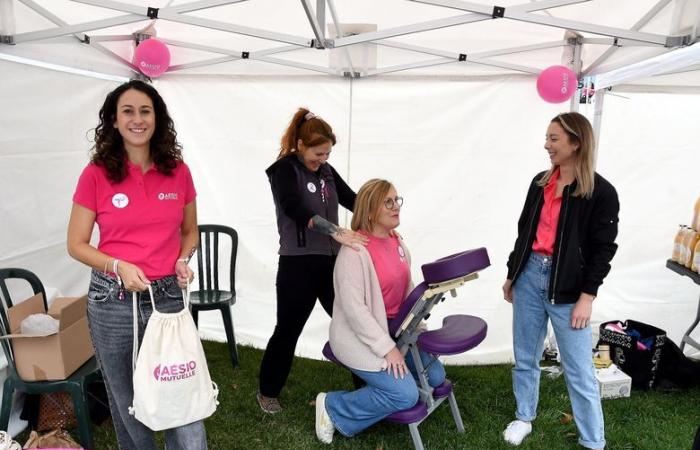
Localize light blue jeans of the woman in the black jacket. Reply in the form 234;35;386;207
513;253;605;448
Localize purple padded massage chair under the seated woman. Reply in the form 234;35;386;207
323;247;491;450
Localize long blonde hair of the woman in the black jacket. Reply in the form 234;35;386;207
537;112;595;198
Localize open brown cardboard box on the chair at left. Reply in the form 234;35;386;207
7;294;94;381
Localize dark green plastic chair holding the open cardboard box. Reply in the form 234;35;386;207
0;269;102;449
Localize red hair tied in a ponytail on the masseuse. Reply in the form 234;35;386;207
277;108;335;159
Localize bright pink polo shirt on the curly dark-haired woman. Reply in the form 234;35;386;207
73;161;197;280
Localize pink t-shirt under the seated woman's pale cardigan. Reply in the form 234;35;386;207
367;235;411;319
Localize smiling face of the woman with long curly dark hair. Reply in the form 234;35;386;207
114;89;156;151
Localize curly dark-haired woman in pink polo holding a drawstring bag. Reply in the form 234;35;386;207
68;80;207;450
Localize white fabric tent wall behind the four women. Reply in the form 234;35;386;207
0;61;700;363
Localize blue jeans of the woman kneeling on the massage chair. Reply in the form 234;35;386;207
326;351;445;437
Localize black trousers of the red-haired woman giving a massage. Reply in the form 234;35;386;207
260;255;335;397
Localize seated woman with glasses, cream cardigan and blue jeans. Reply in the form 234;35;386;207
316;179;445;444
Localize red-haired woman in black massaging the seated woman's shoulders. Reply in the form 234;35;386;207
257;108;367;414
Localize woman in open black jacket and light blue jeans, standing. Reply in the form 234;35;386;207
503;113;620;449
